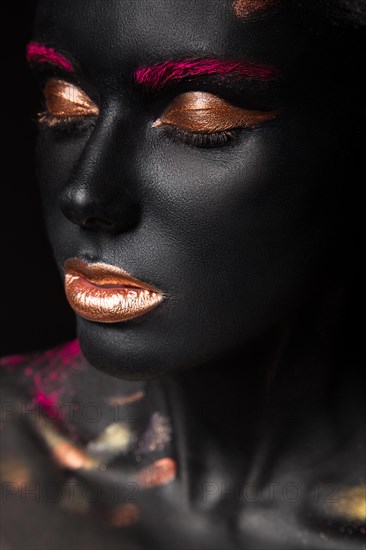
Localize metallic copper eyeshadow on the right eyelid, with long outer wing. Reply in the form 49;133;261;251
153;92;279;133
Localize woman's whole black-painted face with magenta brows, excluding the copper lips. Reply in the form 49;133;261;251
33;0;341;378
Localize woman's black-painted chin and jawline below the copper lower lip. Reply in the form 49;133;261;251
77;300;280;381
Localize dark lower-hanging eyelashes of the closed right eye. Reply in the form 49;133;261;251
159;125;239;149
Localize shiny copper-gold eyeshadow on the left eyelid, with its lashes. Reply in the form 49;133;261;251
38;80;99;126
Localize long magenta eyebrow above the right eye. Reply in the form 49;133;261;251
135;58;280;90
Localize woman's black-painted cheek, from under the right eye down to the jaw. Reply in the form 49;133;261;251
137;117;335;338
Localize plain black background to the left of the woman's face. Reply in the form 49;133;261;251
0;0;75;356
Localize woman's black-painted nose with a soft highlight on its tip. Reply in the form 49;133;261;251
59;119;139;233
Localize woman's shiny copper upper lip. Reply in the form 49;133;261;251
64;258;161;294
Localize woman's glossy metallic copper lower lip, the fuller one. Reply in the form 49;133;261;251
65;274;162;323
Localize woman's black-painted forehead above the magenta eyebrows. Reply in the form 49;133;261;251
34;0;303;74
